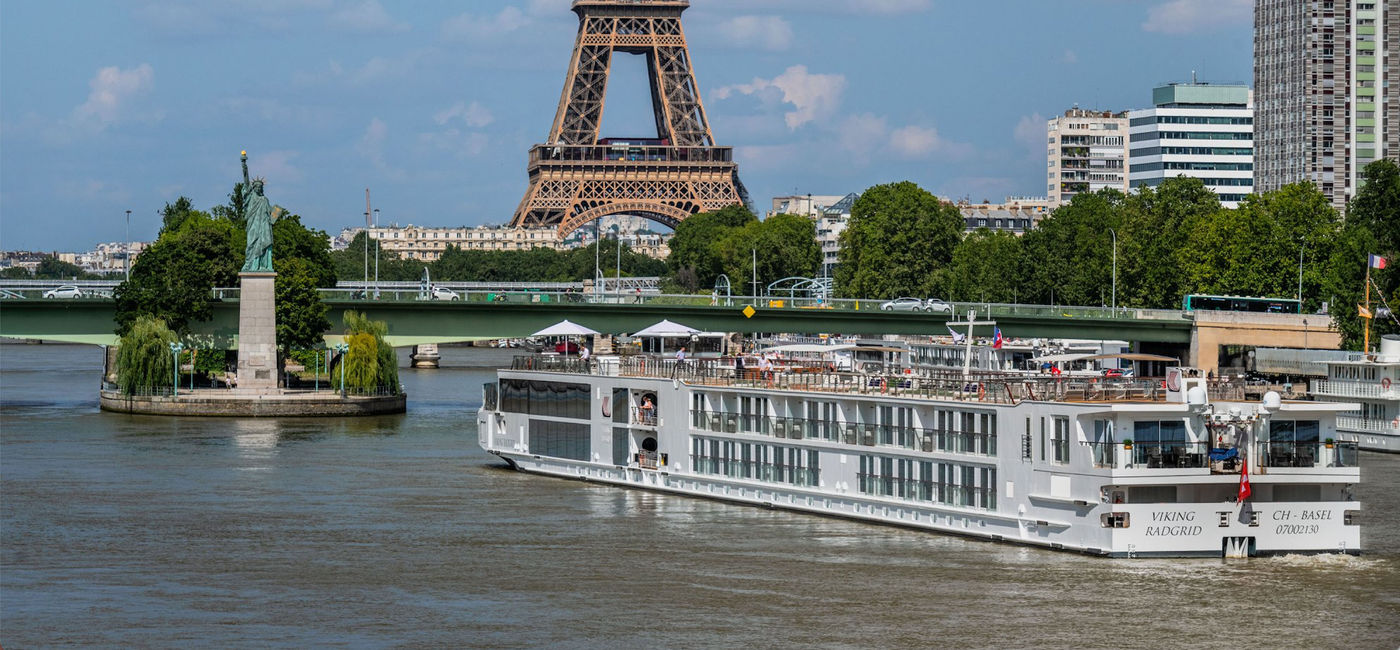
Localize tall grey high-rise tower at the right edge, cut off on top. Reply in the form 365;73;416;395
1254;0;1400;210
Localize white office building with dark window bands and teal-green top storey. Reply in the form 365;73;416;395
1128;81;1254;207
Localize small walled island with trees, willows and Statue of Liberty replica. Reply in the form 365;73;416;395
99;151;406;417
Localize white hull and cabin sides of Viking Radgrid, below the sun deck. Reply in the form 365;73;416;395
477;361;1361;558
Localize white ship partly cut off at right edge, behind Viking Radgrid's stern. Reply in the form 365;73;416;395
1309;335;1400;454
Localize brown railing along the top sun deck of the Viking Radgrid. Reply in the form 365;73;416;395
511;354;1245;403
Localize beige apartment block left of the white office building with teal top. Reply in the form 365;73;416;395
1046;108;1128;205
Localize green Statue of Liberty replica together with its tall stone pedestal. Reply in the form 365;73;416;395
238;151;281;394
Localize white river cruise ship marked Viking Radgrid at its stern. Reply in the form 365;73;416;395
477;356;1361;558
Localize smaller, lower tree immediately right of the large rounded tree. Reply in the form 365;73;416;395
949;228;1022;303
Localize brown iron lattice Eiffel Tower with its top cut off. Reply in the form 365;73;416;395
511;0;748;238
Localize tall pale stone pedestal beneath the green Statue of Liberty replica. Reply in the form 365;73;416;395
238;270;277;394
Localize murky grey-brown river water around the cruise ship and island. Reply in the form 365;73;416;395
0;345;1400;650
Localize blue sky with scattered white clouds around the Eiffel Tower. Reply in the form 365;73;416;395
0;0;1253;251
